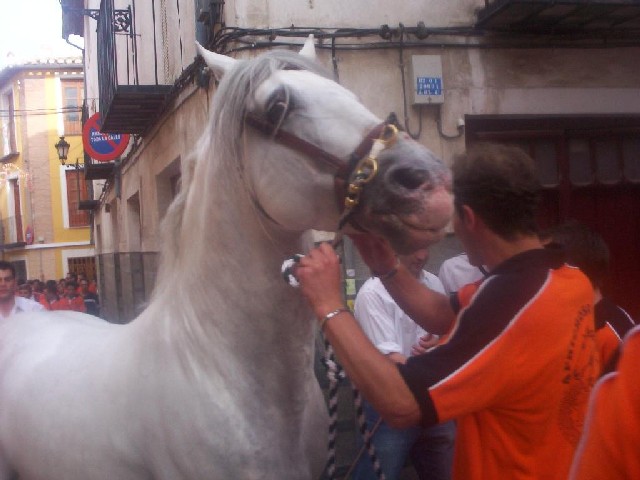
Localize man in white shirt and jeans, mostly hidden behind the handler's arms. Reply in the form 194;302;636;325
353;249;455;480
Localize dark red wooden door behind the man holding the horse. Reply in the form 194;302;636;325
466;116;640;321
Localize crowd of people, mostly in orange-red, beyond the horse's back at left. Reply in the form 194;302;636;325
0;261;100;318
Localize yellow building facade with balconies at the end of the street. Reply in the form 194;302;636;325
0;57;95;280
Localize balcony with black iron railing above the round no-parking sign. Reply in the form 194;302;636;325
97;0;171;135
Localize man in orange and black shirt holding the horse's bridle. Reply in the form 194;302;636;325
297;145;600;480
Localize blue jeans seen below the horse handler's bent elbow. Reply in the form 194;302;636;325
352;401;455;480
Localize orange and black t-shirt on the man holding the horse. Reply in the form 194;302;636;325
398;249;600;480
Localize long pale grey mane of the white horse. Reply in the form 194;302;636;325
154;49;331;296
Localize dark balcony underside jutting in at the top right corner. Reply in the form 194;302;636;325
476;0;640;37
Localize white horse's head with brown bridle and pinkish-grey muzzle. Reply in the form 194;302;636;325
198;37;452;253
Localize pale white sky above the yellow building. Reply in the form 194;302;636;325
0;0;82;69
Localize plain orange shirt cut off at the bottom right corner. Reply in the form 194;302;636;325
569;326;640;480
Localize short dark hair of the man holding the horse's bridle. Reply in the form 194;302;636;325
452;143;541;240
